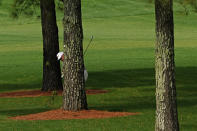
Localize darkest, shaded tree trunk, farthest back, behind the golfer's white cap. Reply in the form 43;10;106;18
40;0;63;91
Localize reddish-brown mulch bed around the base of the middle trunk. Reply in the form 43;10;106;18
10;109;139;120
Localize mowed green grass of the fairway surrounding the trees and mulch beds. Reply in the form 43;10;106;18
0;0;197;131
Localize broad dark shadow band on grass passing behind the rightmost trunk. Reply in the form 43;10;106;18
87;67;197;91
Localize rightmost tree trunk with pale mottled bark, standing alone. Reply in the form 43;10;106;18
155;0;179;131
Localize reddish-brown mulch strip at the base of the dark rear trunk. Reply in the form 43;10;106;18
0;89;107;97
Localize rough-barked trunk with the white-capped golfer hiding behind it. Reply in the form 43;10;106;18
63;0;87;111
